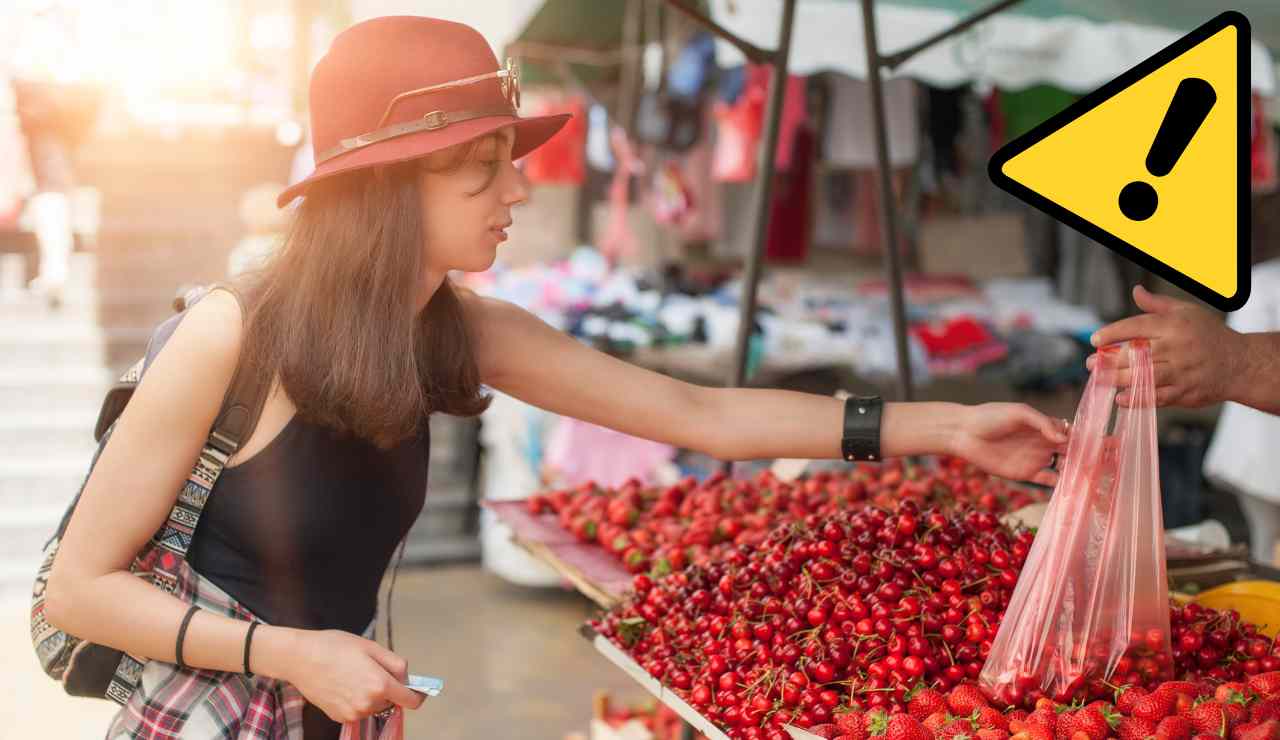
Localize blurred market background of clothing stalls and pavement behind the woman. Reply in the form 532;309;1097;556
0;0;1280;739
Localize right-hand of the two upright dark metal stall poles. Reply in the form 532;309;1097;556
863;0;915;401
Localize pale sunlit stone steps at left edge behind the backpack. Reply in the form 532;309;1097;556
0;253;113;600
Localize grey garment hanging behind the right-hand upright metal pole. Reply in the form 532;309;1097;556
822;73;920;169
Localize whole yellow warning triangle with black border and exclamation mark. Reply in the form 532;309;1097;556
989;12;1251;311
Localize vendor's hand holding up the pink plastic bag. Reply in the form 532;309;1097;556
1085;286;1244;408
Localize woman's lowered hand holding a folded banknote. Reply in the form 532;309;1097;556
282;630;424;722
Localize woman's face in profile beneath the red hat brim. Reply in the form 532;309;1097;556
421;127;529;286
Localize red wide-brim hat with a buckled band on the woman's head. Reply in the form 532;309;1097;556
276;15;570;207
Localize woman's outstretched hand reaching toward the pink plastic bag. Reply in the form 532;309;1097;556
952;403;1069;487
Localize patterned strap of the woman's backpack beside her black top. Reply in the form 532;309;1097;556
106;286;270;704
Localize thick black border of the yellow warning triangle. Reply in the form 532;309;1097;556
987;10;1252;311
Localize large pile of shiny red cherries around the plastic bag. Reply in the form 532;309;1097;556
593;499;1280;740
